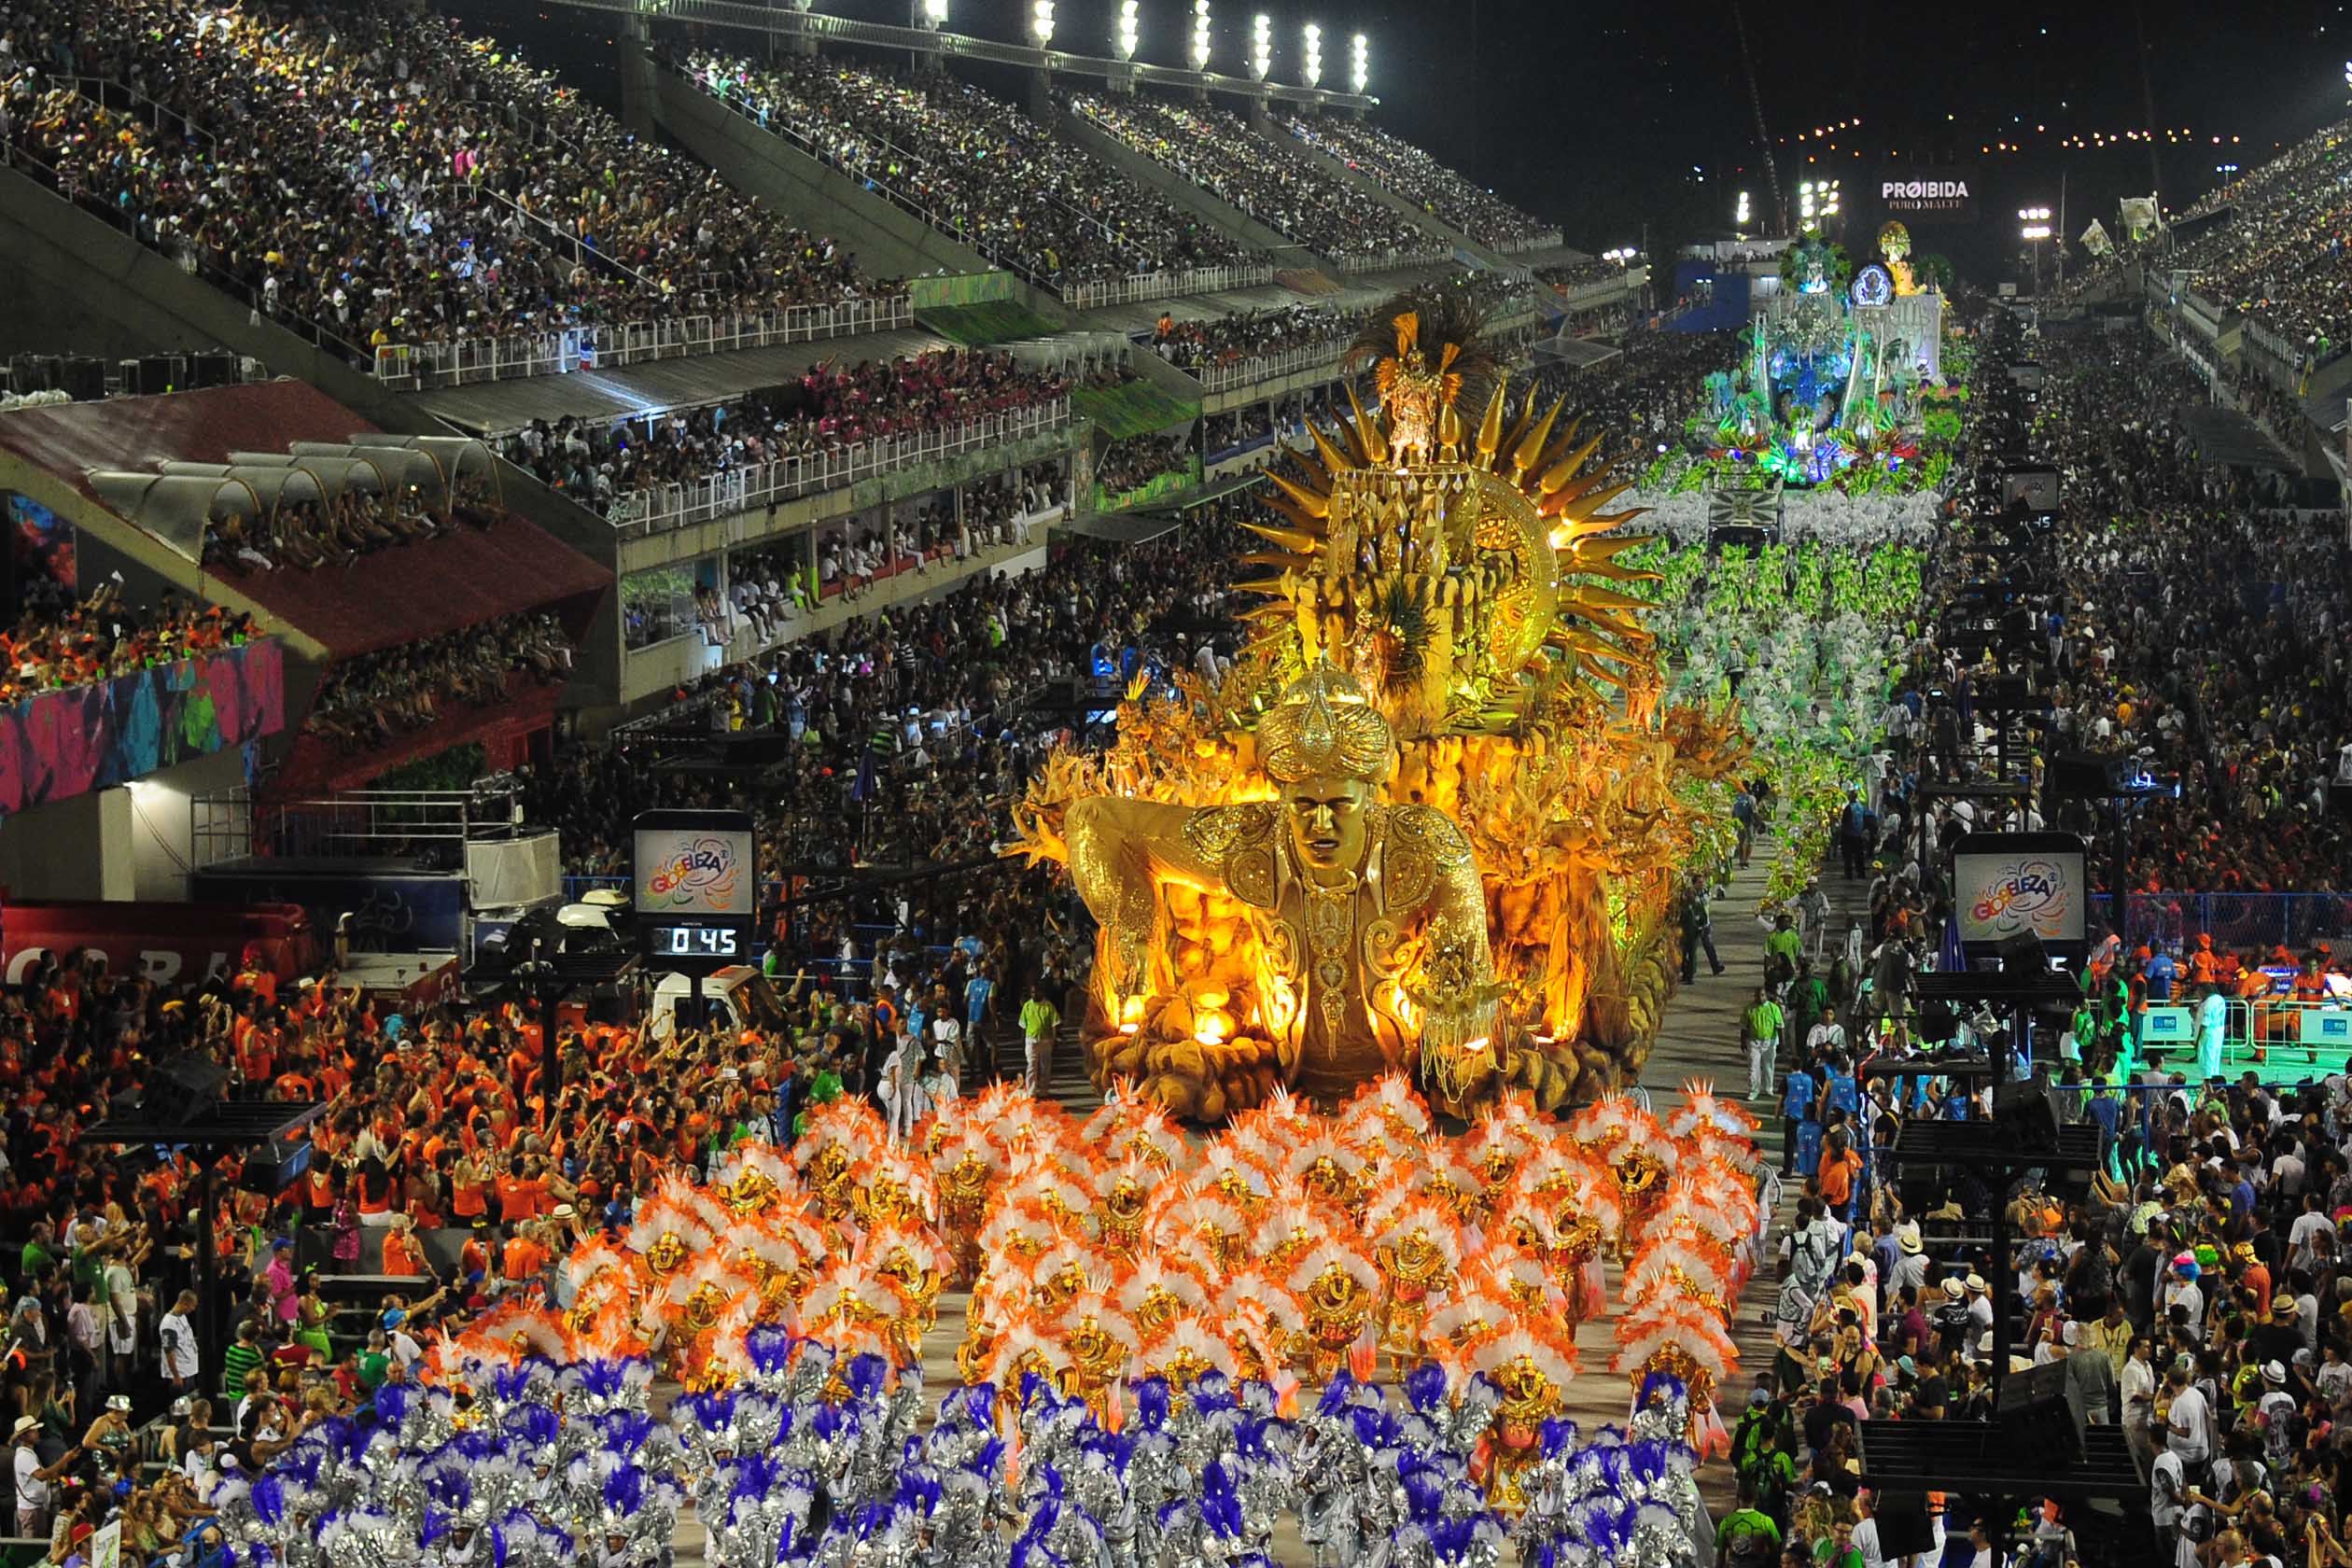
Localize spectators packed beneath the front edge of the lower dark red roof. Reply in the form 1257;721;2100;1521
303;611;571;752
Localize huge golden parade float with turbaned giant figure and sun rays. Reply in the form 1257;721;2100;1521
1016;296;1741;1121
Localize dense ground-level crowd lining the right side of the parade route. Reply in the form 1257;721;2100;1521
1712;305;2352;1568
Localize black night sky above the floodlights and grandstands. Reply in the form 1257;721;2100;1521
477;0;2352;282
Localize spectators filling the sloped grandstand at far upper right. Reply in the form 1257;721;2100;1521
2162;124;2352;362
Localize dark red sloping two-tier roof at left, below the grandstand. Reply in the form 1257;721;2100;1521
0;381;611;658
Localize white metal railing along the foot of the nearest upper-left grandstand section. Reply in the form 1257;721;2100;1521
370;294;915;393
